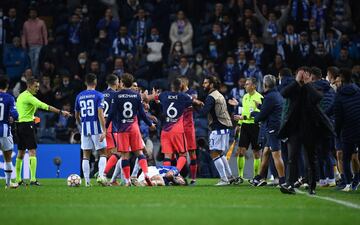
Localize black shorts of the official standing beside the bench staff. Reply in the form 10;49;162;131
239;123;260;150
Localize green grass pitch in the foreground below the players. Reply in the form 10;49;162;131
0;179;360;225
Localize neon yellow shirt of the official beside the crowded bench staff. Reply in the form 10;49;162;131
240;91;263;124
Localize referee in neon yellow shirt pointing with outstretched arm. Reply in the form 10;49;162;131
15;78;71;186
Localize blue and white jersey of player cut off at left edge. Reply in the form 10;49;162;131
0;92;19;137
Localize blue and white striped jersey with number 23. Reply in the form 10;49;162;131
75;90;104;136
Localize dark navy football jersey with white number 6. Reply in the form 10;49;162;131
159;91;192;133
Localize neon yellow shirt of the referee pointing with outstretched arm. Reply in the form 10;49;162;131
16;90;49;122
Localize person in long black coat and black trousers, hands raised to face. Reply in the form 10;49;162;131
279;67;334;194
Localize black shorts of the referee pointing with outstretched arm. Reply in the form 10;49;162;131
16;122;37;150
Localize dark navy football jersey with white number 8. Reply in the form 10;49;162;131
106;89;152;132
